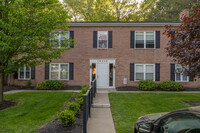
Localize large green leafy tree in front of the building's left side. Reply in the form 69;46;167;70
0;0;72;102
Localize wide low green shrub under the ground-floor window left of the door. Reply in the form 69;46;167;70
36;80;64;90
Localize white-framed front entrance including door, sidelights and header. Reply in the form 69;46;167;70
90;59;115;88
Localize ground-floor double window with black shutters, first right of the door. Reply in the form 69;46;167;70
135;64;155;81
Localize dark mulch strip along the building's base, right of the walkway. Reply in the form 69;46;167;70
116;86;200;91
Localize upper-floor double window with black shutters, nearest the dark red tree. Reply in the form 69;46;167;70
135;31;155;48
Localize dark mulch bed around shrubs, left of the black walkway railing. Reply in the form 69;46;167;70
37;96;83;133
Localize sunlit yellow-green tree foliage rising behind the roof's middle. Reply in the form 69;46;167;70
64;0;137;22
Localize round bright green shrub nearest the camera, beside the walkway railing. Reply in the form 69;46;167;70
58;109;75;126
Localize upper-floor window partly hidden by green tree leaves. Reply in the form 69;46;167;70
51;31;69;48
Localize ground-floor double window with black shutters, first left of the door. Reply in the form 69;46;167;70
50;63;69;80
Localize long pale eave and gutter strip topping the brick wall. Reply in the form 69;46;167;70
69;21;182;27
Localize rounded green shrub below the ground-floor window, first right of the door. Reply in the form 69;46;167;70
138;80;157;91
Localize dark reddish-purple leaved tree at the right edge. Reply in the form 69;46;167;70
164;5;200;77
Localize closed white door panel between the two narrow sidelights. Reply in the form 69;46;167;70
97;63;109;88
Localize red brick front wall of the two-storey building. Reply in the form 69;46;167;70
8;27;200;88
